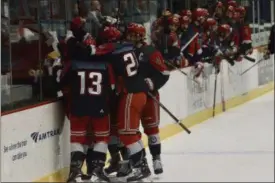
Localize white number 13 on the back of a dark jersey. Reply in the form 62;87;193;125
77;71;102;95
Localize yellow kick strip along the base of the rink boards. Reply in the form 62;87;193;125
34;82;274;182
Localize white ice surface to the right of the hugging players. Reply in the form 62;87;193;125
147;92;274;182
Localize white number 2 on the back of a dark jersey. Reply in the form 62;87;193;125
123;53;138;77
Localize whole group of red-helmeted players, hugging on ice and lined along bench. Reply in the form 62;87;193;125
49;1;252;182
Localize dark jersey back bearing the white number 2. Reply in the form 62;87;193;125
109;43;149;93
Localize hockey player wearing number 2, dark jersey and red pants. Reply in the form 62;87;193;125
95;27;151;181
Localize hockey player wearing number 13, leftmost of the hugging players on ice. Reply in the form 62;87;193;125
57;17;114;182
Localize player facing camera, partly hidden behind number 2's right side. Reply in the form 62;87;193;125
128;24;169;174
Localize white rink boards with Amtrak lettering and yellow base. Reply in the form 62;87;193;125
1;50;274;182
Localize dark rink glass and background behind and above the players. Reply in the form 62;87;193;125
1;0;275;114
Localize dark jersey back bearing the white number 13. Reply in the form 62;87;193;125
70;59;111;117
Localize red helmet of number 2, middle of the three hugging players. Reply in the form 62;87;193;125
99;26;121;42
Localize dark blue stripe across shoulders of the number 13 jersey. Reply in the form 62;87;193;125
72;60;106;70
